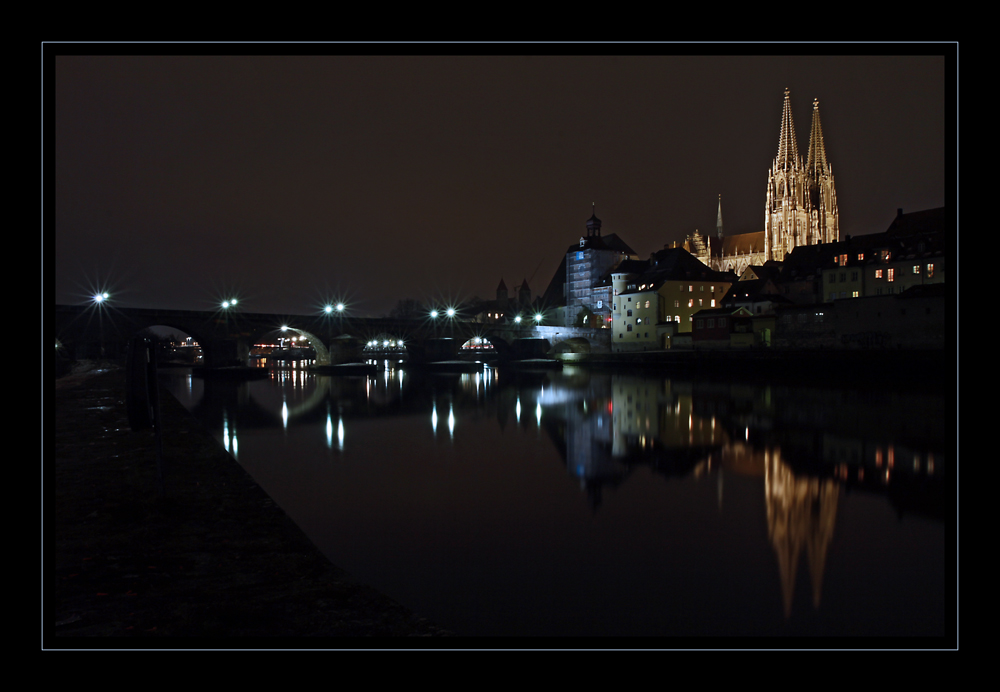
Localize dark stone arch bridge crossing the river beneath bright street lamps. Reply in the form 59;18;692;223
60;305;611;367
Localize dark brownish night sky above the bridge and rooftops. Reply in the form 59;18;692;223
46;46;955;314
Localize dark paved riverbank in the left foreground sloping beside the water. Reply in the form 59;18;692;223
42;368;451;649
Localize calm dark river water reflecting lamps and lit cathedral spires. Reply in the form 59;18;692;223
162;363;956;646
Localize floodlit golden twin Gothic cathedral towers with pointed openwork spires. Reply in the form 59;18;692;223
764;89;840;261
